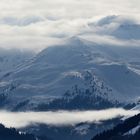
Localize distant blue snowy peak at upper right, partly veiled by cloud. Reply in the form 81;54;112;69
89;15;140;40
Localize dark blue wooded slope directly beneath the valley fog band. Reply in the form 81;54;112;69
21;118;120;140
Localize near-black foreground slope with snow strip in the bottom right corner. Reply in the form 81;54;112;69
92;114;140;140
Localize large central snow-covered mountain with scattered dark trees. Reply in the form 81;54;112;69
0;37;140;110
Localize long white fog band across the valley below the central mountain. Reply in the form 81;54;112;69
0;108;139;128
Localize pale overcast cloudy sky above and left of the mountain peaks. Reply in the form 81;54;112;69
0;0;140;47
